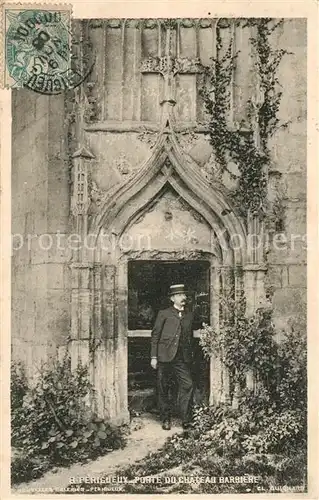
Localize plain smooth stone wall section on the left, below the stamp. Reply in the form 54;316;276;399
12;90;70;372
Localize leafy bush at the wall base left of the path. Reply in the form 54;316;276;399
11;357;125;482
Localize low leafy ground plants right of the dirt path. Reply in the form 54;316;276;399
113;400;306;494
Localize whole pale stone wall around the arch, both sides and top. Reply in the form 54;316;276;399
12;19;307;382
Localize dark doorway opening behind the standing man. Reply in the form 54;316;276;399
128;260;211;412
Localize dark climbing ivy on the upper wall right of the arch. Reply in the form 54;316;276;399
201;18;288;216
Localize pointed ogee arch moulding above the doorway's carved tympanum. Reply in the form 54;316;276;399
91;131;246;266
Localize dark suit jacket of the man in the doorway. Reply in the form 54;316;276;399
151;307;194;363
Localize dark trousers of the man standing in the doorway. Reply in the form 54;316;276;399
157;358;194;424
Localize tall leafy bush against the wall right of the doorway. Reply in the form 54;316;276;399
195;296;307;455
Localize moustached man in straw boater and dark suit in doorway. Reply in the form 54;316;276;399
151;285;194;433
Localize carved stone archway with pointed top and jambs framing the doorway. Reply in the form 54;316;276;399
71;116;264;422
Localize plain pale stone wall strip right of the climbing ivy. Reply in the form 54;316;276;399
268;19;307;328
